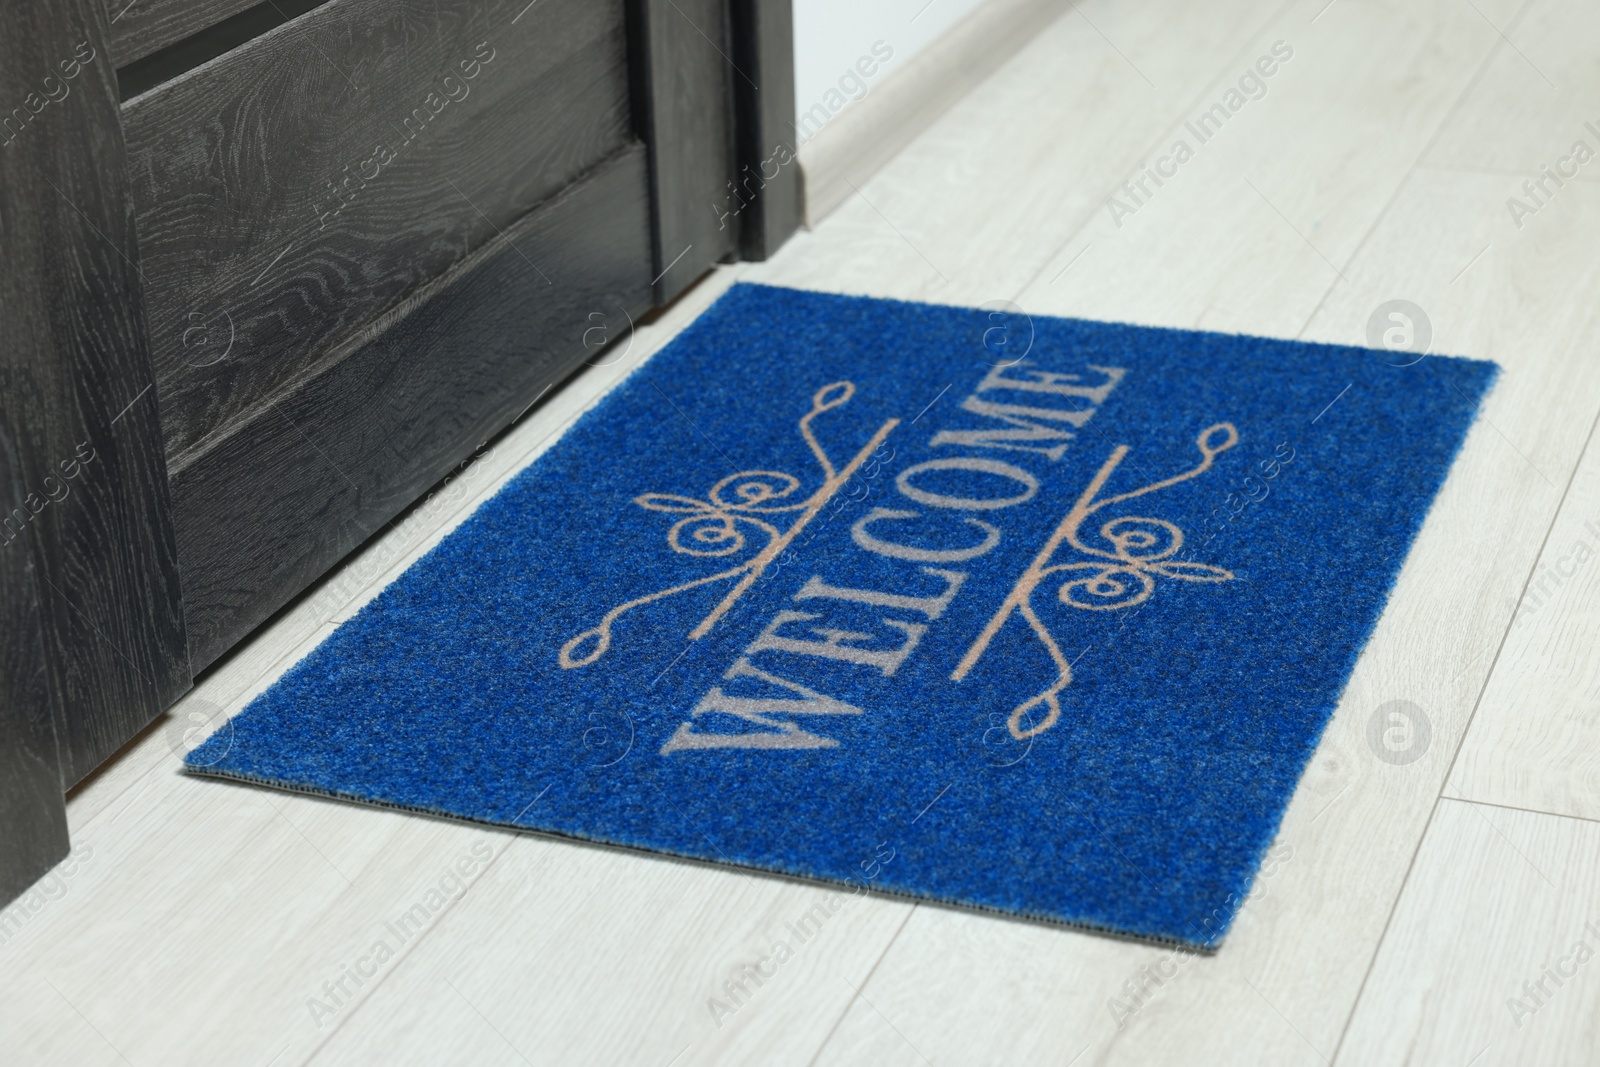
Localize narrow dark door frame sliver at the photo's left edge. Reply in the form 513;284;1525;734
0;422;67;908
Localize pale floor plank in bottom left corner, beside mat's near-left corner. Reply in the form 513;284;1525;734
0;776;509;1064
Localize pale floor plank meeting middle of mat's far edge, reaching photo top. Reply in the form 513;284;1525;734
1018;2;1498;334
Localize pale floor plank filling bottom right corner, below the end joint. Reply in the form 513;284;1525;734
1336;800;1600;1067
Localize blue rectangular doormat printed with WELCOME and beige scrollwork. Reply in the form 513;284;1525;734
189;285;1498;949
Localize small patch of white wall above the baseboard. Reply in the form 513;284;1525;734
794;0;984;142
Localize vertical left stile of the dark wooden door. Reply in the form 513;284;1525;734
0;0;190;784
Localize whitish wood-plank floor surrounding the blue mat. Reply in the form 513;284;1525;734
9;0;1600;1067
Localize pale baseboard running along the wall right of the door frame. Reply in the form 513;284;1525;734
798;0;1072;229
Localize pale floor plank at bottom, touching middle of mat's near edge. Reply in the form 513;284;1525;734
300;838;910;1064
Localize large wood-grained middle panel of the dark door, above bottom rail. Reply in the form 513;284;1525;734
123;0;630;467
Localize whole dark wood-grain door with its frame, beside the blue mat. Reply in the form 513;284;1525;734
0;0;798;896
